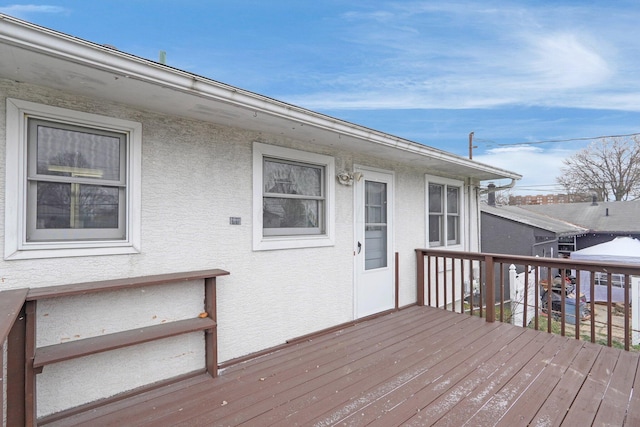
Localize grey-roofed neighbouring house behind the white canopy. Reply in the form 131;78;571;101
520;200;640;255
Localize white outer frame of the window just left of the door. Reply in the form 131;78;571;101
253;142;335;251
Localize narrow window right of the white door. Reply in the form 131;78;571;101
427;177;462;247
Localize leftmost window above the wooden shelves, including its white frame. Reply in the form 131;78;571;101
5;100;141;259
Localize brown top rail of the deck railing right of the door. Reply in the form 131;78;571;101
416;249;640;276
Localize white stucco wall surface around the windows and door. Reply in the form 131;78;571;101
0;80;478;414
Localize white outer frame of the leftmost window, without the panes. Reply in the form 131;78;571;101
4;98;142;260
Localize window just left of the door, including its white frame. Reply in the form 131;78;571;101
253;143;334;250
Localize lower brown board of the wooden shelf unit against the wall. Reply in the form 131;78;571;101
33;317;216;368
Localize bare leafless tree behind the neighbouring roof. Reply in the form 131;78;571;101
556;136;640;201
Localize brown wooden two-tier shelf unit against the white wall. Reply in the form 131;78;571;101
0;269;229;426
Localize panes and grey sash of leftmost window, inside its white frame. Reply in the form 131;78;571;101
26;118;127;242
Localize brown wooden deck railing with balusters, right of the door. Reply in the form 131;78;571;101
416;249;640;350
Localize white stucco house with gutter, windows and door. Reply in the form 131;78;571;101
0;15;520;415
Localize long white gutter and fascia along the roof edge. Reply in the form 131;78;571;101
0;14;522;179
